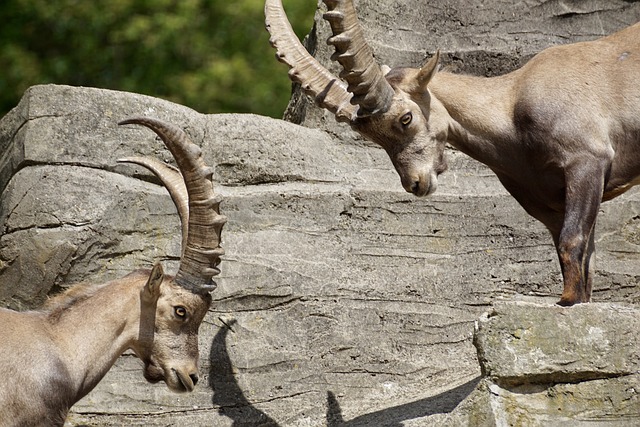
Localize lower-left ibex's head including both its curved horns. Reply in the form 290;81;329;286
120;118;226;391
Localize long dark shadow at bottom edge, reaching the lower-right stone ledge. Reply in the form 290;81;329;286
327;377;481;427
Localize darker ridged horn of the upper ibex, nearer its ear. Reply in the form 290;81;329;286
322;0;394;116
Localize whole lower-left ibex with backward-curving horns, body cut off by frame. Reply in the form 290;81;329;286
0;118;226;427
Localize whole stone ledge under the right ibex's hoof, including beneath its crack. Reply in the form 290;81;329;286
460;303;640;426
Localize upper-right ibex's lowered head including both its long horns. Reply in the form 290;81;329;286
265;0;447;196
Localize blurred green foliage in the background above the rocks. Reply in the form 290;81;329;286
0;0;316;117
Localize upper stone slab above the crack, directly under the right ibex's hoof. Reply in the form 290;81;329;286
476;303;640;386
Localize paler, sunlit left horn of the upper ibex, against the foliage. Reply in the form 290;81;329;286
264;0;357;122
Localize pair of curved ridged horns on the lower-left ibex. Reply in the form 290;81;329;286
118;117;227;292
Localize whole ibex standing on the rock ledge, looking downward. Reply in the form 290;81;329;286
265;0;640;306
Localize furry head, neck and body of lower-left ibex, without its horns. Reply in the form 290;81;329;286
0;267;211;427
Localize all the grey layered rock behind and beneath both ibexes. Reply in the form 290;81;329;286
0;0;640;426
